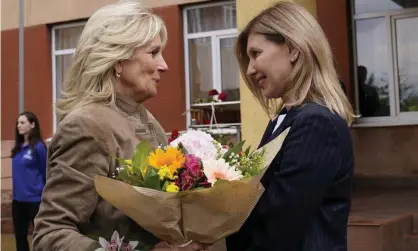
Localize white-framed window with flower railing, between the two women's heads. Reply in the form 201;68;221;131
183;2;240;137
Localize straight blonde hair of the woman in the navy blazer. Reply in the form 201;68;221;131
236;1;355;124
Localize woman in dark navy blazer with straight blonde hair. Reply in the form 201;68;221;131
227;2;354;251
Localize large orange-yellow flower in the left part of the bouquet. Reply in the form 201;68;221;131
148;146;185;175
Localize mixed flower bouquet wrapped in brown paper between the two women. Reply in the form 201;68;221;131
95;129;289;249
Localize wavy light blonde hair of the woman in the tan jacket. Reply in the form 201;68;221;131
57;0;167;118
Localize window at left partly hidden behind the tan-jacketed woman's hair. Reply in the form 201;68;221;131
52;23;85;131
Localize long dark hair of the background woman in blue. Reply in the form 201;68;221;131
12;112;45;157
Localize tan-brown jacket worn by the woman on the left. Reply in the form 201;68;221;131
33;95;167;251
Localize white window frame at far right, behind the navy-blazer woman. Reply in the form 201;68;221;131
351;0;418;127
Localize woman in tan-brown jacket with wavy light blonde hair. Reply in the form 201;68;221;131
33;1;207;251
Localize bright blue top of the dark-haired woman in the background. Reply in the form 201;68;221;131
12;142;47;202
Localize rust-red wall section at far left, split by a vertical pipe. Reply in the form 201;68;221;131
1;25;52;140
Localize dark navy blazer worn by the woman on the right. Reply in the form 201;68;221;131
227;103;354;251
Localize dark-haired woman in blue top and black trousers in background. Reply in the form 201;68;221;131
12;112;47;251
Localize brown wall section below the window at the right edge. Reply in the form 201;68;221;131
351;126;418;179
